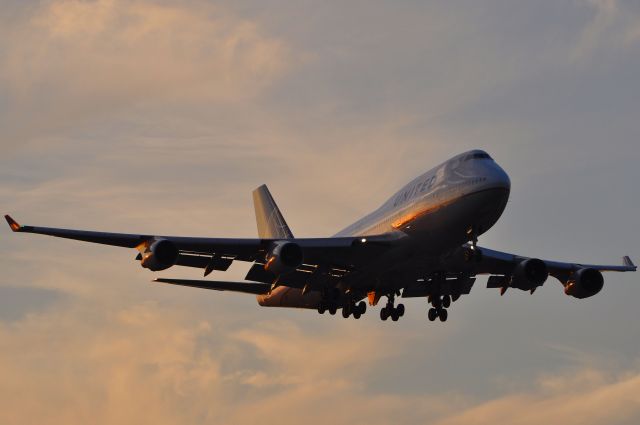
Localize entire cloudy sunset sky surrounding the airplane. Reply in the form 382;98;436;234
0;0;640;425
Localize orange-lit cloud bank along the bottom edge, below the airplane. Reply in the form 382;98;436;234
0;292;640;425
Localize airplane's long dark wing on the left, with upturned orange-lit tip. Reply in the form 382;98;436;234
5;215;394;270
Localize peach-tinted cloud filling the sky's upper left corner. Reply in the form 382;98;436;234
0;0;292;142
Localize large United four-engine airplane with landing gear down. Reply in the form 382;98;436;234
5;150;636;322
